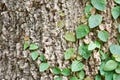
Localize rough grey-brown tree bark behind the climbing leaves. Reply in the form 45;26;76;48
0;0;115;80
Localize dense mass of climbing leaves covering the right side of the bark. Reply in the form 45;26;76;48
64;0;120;80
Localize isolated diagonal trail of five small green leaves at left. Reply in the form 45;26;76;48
24;41;49;72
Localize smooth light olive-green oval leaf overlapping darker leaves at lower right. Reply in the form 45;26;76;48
104;60;117;71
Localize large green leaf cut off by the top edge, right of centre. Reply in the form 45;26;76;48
91;0;106;11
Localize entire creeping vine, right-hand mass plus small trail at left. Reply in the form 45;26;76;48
24;0;120;80
